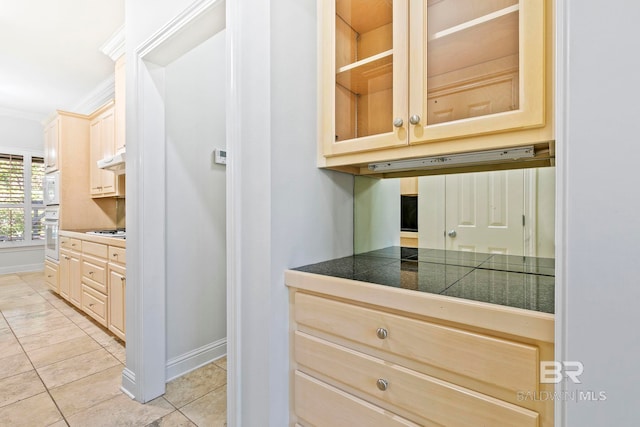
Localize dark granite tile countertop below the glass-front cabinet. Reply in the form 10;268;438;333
294;246;555;313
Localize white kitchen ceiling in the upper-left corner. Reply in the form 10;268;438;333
0;0;124;120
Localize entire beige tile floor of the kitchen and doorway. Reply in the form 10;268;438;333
0;273;227;427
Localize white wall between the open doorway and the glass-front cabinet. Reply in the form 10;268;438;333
227;0;353;426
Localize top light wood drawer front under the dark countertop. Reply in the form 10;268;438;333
294;292;539;391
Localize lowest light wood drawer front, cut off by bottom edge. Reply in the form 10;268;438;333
294;371;418;427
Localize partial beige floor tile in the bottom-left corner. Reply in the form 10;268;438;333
0;393;66;427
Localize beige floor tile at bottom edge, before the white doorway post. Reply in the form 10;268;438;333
67;394;175;427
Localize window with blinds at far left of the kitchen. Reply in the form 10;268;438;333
0;153;44;245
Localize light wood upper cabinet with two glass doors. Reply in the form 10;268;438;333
318;0;554;173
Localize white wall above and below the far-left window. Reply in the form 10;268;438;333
0;112;44;274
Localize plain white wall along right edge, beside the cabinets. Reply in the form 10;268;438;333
556;0;640;427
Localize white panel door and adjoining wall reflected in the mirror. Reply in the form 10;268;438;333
418;168;554;257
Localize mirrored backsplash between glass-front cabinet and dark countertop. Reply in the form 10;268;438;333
354;167;555;258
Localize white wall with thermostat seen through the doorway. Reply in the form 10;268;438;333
165;32;227;380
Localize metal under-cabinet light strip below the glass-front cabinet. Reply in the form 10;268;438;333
368;146;535;172
